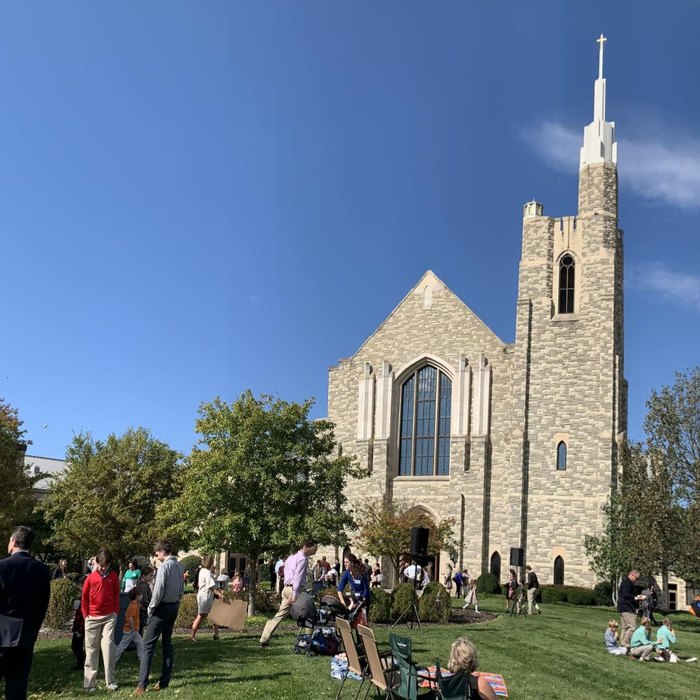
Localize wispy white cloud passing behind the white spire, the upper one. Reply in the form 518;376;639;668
521;121;700;209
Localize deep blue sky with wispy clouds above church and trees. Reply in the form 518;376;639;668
0;0;700;457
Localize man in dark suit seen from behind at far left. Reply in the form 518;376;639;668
0;525;51;700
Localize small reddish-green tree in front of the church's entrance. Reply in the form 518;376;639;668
355;500;455;575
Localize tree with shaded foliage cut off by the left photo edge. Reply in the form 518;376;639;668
0;398;39;542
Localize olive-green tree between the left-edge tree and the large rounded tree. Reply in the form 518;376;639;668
43;428;180;564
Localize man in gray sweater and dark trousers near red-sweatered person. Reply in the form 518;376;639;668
133;540;185;697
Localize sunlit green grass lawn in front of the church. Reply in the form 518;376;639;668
24;597;700;700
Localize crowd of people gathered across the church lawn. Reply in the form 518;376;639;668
0;526;700;700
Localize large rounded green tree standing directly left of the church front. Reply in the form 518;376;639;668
161;391;361;615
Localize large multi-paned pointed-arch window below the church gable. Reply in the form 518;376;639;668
399;365;452;476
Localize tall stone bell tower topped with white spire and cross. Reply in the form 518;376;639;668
513;34;627;585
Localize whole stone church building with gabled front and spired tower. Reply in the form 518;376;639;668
328;36;627;586
